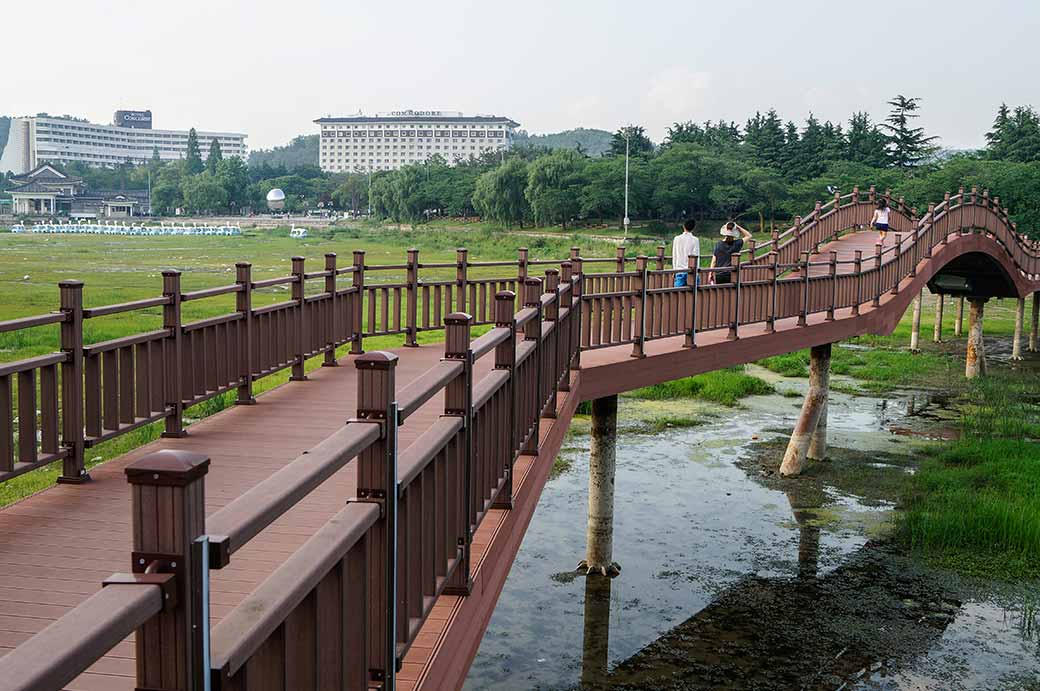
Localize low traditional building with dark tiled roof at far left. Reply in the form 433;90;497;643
4;163;151;219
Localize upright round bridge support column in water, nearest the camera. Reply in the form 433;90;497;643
578;395;621;575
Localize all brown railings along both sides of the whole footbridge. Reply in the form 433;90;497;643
0;185;1040;690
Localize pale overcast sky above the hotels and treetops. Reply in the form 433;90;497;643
6;0;1040;148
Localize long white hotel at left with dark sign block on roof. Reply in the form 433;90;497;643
0;110;249;175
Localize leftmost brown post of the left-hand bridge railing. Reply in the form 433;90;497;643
57;281;90;484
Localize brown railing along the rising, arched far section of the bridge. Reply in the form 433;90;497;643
581;188;1040;356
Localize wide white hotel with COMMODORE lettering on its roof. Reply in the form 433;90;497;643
314;110;520;173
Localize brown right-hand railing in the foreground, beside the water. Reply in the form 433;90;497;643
0;266;581;691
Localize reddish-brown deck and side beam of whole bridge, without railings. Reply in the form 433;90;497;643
0;227;1027;691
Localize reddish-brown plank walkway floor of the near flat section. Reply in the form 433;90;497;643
0;344;503;691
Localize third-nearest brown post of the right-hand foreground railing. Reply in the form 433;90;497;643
440;312;474;595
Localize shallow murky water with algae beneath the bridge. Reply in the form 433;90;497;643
466;380;1040;689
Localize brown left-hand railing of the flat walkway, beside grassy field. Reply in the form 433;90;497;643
0;249;577;489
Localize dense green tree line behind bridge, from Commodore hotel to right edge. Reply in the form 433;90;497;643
355;95;1040;237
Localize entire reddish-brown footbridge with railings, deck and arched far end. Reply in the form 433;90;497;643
0;188;1040;691
